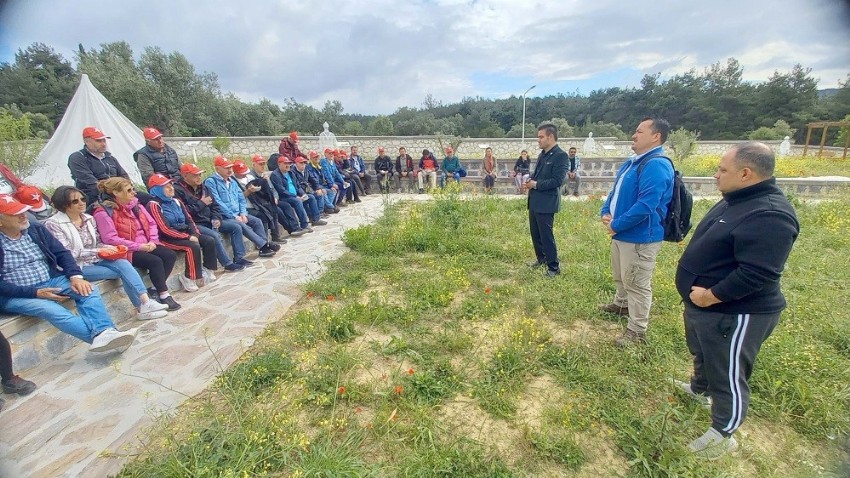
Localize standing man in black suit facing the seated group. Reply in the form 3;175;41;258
524;124;569;278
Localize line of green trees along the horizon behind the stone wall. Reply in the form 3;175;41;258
0;42;850;143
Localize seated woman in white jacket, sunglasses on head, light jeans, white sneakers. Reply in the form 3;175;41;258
44;186;168;320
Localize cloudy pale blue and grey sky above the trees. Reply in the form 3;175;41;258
0;0;850;114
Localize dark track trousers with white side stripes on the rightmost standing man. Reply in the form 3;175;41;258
684;304;780;436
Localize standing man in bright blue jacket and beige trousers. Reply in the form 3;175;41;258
599;118;673;347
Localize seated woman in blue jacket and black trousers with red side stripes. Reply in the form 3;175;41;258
148;174;218;292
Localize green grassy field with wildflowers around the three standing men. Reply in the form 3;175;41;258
119;191;850;477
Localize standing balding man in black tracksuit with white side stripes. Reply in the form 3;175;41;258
676;142;800;459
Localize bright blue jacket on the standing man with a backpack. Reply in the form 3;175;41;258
600;146;673;244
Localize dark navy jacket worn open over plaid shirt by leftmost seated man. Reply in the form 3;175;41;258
0;222;83;307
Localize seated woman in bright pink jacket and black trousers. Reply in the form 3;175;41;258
92;177;180;310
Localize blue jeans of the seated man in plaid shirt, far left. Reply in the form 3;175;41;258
3;276;115;343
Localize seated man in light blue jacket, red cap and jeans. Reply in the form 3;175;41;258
204;156;280;257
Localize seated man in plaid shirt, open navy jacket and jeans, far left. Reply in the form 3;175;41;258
0;195;138;352
